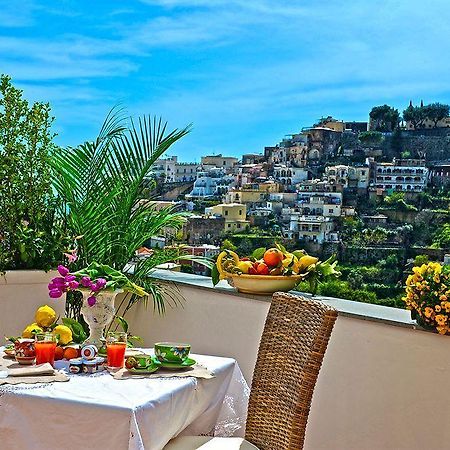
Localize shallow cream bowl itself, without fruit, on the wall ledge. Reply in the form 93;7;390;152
227;274;303;295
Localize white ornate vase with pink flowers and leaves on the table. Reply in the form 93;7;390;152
48;262;149;347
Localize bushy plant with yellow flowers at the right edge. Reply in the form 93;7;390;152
403;262;450;334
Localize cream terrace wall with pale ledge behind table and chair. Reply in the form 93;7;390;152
0;271;450;450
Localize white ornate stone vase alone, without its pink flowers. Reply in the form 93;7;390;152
80;289;123;348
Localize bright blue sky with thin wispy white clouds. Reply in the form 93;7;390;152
0;0;450;161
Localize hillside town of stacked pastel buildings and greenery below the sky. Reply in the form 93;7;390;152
139;102;450;306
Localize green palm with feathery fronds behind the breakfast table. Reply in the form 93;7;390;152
51;108;202;318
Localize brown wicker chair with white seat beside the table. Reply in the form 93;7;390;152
165;292;337;450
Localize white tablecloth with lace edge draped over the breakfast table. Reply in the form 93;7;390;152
0;355;249;450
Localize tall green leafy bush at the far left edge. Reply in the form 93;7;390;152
0;75;70;271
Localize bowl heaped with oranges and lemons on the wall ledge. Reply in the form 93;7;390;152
212;244;339;295
